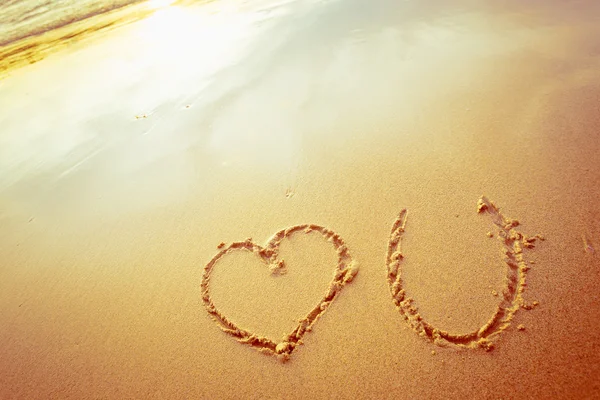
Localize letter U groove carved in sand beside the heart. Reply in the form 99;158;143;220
386;196;543;350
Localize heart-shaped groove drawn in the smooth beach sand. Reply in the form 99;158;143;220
201;224;358;361
